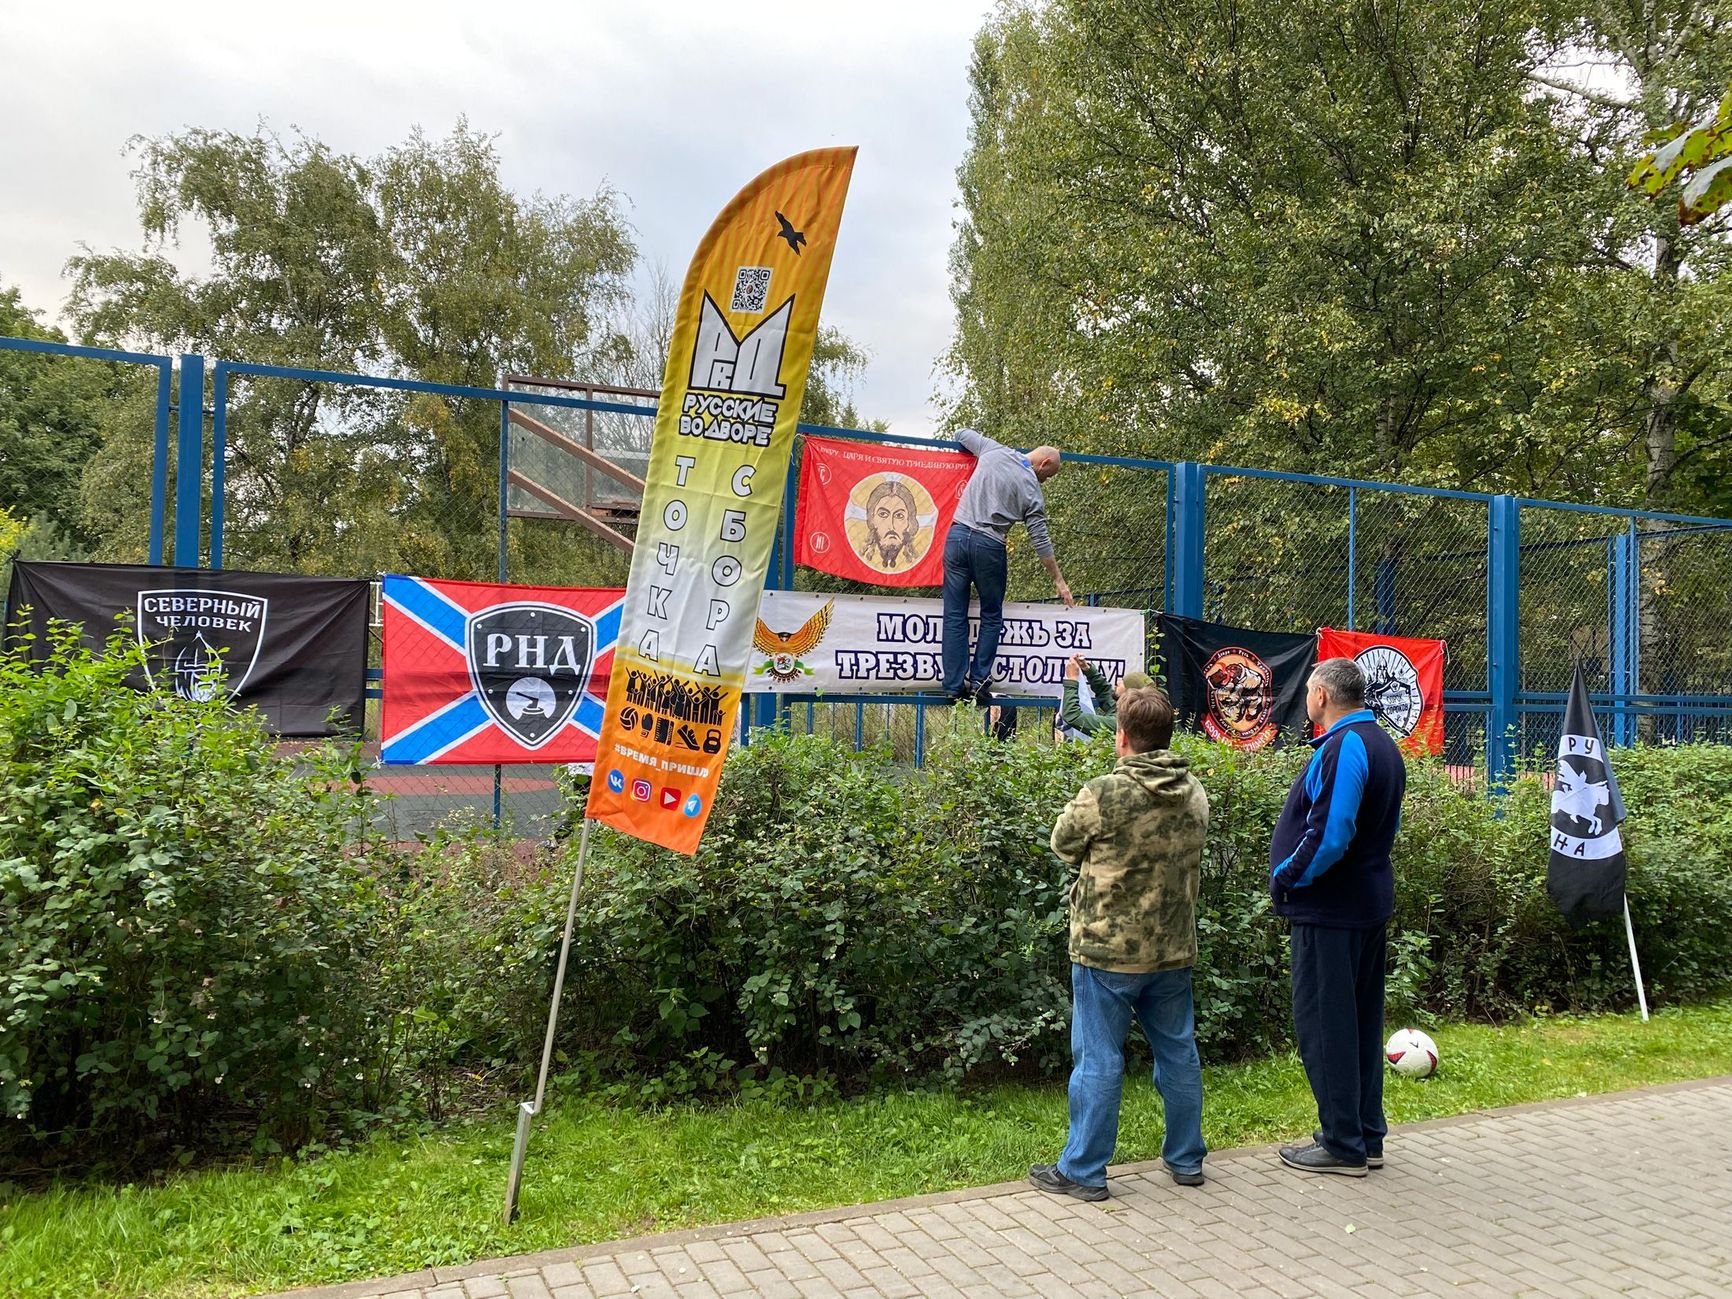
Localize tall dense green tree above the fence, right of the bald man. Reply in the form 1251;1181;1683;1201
951;0;1614;487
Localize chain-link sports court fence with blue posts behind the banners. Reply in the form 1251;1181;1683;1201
13;339;1732;835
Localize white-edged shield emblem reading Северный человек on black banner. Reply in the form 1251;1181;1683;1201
133;589;270;700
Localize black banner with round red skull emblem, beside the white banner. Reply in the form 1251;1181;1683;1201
1155;613;1316;750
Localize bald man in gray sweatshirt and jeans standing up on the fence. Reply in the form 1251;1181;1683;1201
944;428;1076;708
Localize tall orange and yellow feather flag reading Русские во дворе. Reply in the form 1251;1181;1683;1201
589;149;854;852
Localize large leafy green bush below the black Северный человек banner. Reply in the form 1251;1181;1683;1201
0;634;378;1159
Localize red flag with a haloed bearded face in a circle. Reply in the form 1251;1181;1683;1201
793;438;975;587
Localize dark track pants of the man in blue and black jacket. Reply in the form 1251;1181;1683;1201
1292;925;1389;1162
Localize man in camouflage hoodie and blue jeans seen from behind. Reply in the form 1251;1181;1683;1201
1029;686;1209;1200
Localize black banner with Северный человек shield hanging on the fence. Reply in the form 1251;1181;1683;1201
5;561;367;736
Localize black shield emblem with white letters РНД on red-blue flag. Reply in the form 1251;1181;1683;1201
464;601;596;748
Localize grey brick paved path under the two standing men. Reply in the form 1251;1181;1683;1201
280;1077;1732;1299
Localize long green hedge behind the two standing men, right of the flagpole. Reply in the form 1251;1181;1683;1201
502;724;1732;1093
